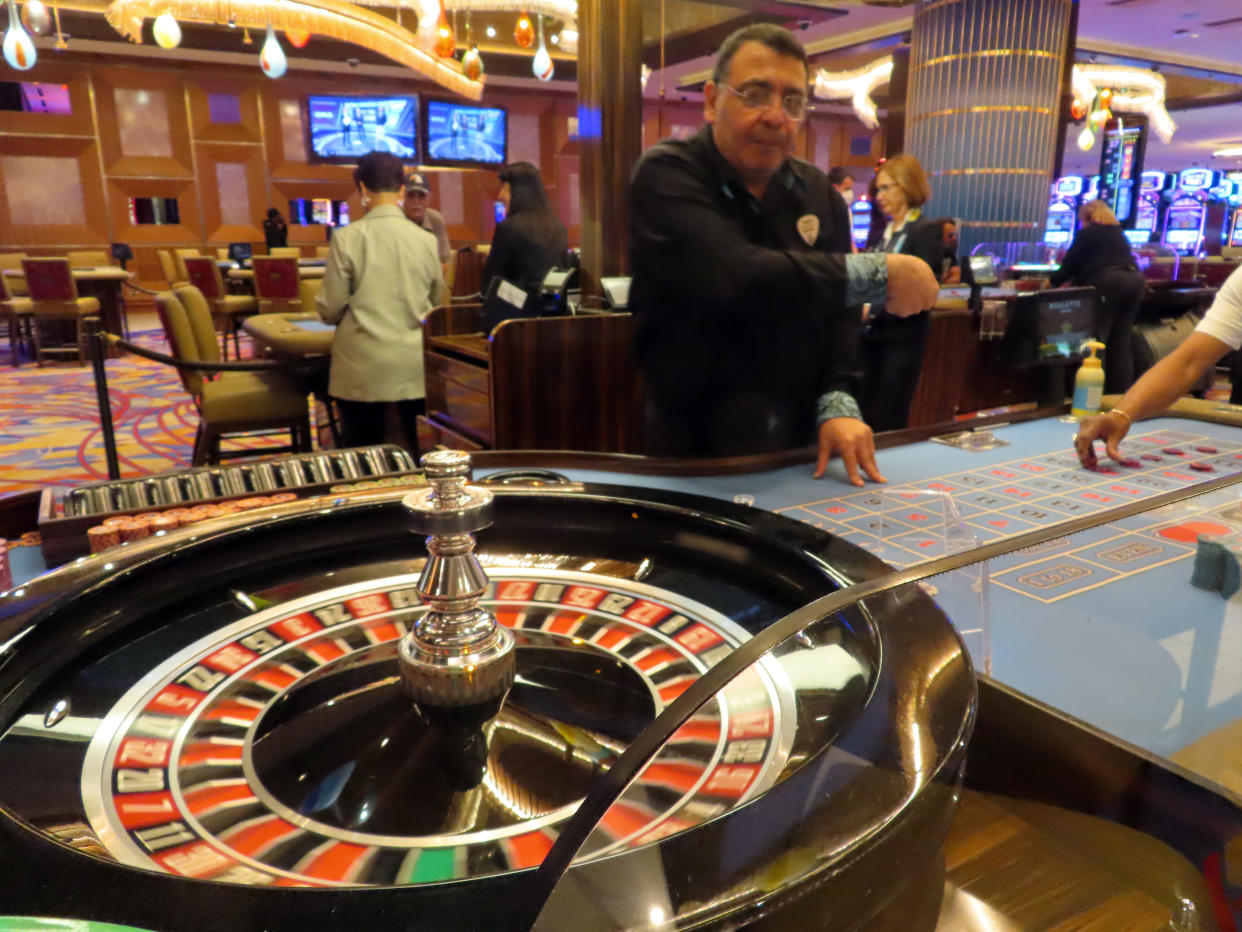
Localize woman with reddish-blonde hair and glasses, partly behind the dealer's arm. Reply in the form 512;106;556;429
858;154;944;430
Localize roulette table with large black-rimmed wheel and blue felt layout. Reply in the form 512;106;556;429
0;405;1242;930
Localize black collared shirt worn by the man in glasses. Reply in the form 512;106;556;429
630;127;859;456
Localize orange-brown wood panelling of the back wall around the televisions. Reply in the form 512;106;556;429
0;56;878;285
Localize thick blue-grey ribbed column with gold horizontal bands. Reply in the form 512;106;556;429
905;0;1077;251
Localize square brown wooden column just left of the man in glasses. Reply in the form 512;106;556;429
578;0;642;295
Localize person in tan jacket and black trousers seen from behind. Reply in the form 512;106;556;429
315;152;442;454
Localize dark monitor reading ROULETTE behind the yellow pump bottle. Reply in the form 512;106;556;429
1004;288;1095;364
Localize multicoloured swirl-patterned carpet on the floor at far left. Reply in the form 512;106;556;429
0;329;299;496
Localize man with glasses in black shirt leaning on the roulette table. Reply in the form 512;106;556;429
630;25;936;485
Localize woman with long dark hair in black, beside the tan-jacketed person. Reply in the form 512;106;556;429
482;162;569;332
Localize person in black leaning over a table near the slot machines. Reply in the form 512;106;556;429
1049;200;1146;395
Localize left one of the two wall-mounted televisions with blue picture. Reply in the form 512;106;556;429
307;94;419;163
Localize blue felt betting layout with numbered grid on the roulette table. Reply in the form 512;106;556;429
553;418;1242;756
